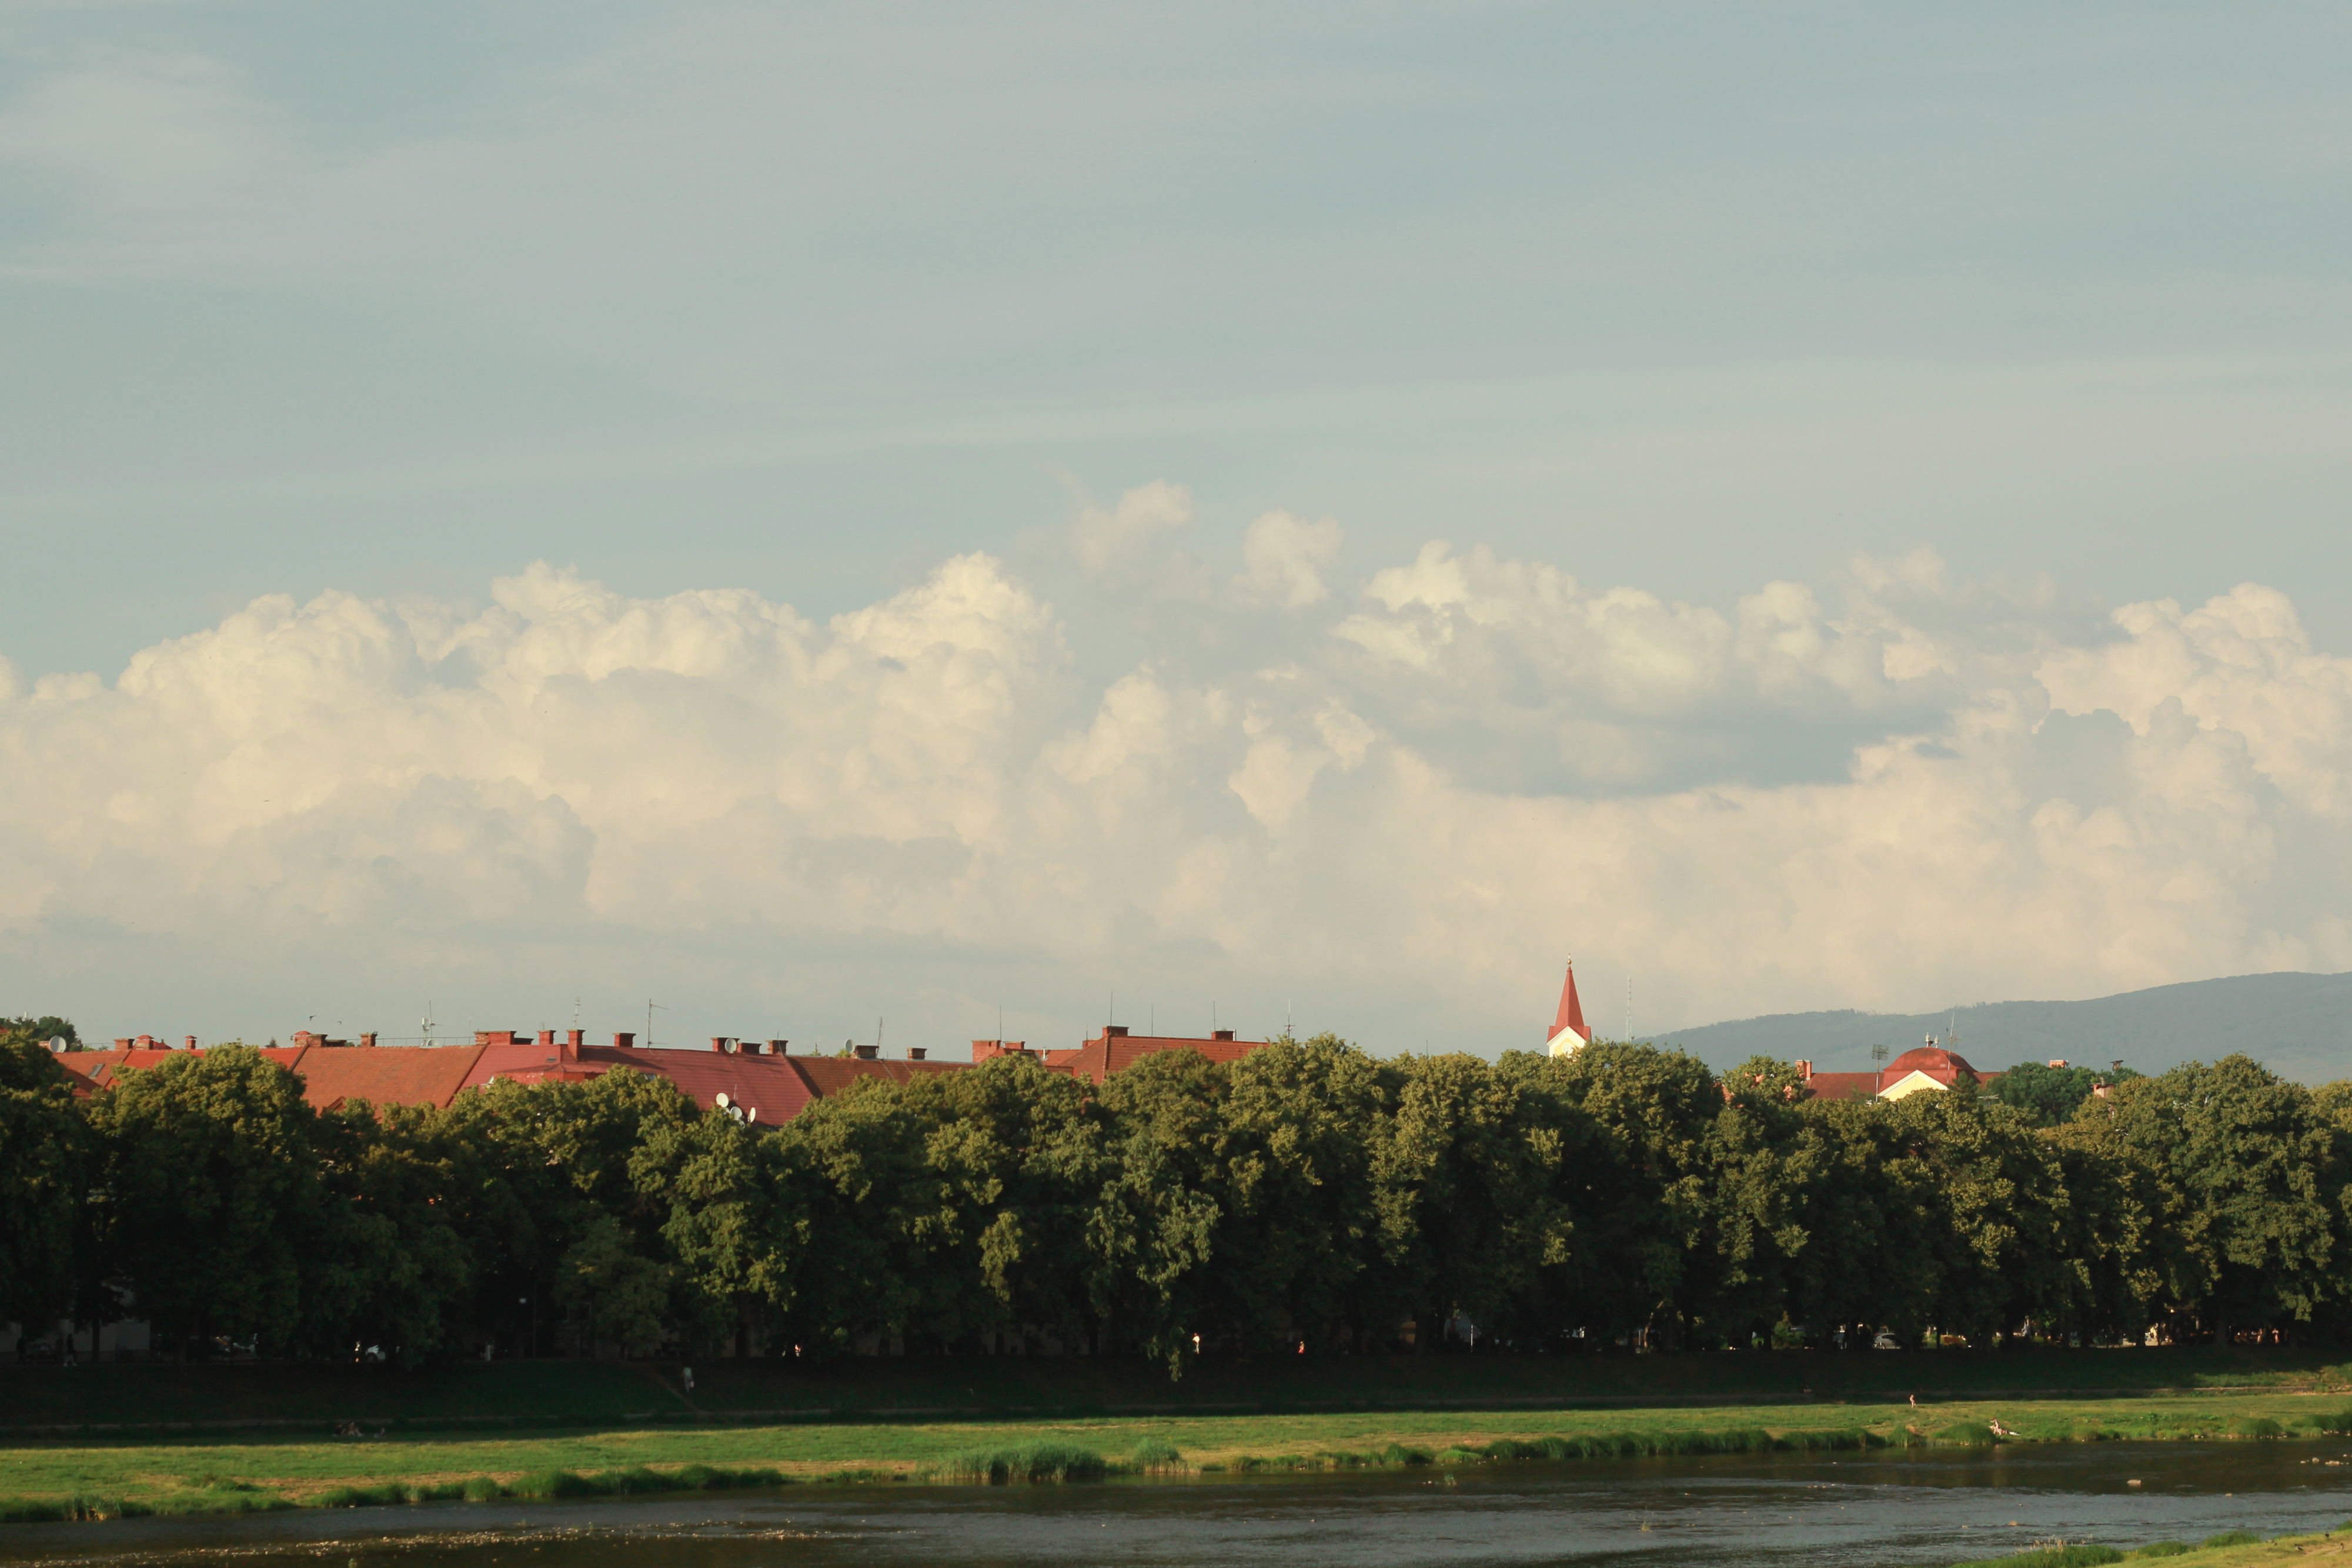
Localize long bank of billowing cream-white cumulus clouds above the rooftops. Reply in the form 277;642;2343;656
0;484;2352;1048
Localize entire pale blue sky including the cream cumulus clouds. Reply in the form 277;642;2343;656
0;0;2352;1053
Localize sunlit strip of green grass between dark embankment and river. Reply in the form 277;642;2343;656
0;1389;2352;1519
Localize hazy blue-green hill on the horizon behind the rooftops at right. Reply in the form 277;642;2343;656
1668;973;2352;1084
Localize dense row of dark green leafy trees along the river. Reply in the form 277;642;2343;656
0;1020;2352;1368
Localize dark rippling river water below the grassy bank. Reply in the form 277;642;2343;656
0;1441;2352;1568
